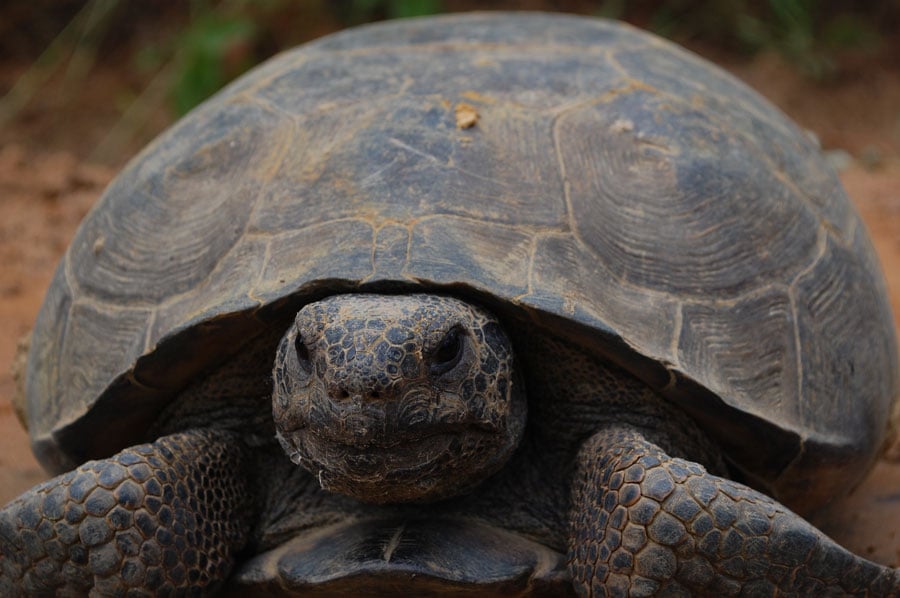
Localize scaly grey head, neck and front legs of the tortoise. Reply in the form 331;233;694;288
0;295;900;596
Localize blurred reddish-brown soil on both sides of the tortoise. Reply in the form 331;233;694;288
0;19;900;565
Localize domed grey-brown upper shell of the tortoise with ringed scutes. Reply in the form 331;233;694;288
26;13;898;510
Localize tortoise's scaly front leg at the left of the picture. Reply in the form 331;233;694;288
0;430;253;596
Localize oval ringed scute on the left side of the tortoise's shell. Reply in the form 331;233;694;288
69;103;288;306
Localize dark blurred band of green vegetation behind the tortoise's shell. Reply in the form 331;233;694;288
0;0;900;134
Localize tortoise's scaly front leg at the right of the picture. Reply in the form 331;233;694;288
569;427;900;596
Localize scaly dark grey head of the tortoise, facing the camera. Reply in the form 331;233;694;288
273;294;526;503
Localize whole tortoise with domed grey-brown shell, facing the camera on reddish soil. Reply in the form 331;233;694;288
0;13;900;595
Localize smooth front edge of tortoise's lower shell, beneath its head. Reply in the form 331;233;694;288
232;517;572;596
